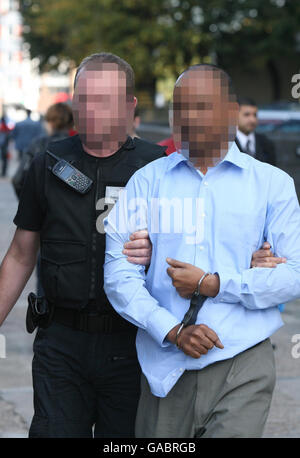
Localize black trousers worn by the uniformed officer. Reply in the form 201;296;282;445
29;322;140;438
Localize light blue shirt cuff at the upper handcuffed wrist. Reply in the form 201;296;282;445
212;272;242;304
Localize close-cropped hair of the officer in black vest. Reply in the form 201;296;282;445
74;52;134;95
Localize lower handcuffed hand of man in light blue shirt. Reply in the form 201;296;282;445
167;324;224;358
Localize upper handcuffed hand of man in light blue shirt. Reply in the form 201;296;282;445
166;258;220;299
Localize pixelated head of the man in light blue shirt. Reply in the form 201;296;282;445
173;69;238;166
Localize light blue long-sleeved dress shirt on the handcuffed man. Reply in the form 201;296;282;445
104;143;300;397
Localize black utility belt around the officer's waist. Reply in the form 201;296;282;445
53;308;136;334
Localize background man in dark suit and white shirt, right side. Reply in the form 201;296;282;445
235;97;276;165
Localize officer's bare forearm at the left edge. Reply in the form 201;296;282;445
0;252;36;326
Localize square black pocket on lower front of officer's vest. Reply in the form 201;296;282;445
41;240;88;303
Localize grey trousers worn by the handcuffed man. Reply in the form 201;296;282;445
135;339;276;438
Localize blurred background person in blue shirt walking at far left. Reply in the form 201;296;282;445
12;109;44;159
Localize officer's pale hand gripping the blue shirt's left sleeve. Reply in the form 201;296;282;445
122;230;152;266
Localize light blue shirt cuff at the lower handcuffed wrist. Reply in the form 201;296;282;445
147;307;180;347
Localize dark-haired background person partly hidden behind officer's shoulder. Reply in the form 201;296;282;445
12;103;75;198
